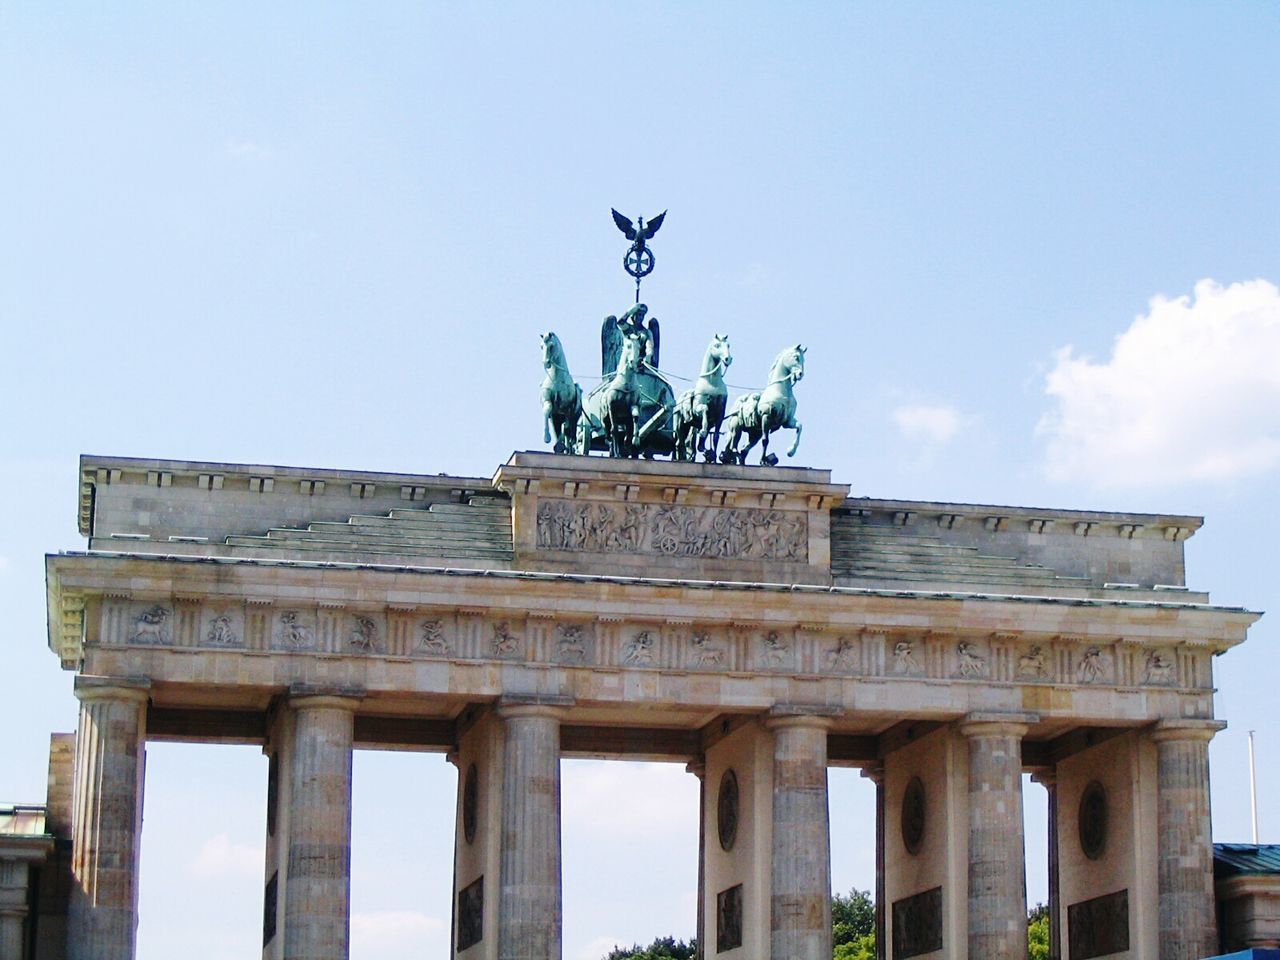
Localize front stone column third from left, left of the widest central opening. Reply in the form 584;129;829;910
498;703;563;960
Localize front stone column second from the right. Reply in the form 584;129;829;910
960;713;1034;960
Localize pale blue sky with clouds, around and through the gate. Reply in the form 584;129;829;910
0;3;1280;960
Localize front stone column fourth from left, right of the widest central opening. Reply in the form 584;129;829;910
767;716;831;960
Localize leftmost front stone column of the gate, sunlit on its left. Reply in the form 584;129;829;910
67;677;150;960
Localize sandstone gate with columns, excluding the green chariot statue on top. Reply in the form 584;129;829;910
47;453;1256;960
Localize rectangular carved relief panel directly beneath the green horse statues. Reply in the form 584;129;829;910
538;499;809;563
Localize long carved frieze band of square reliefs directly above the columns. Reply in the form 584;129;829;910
88;601;1208;690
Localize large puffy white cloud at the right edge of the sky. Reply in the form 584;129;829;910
1037;280;1280;486
